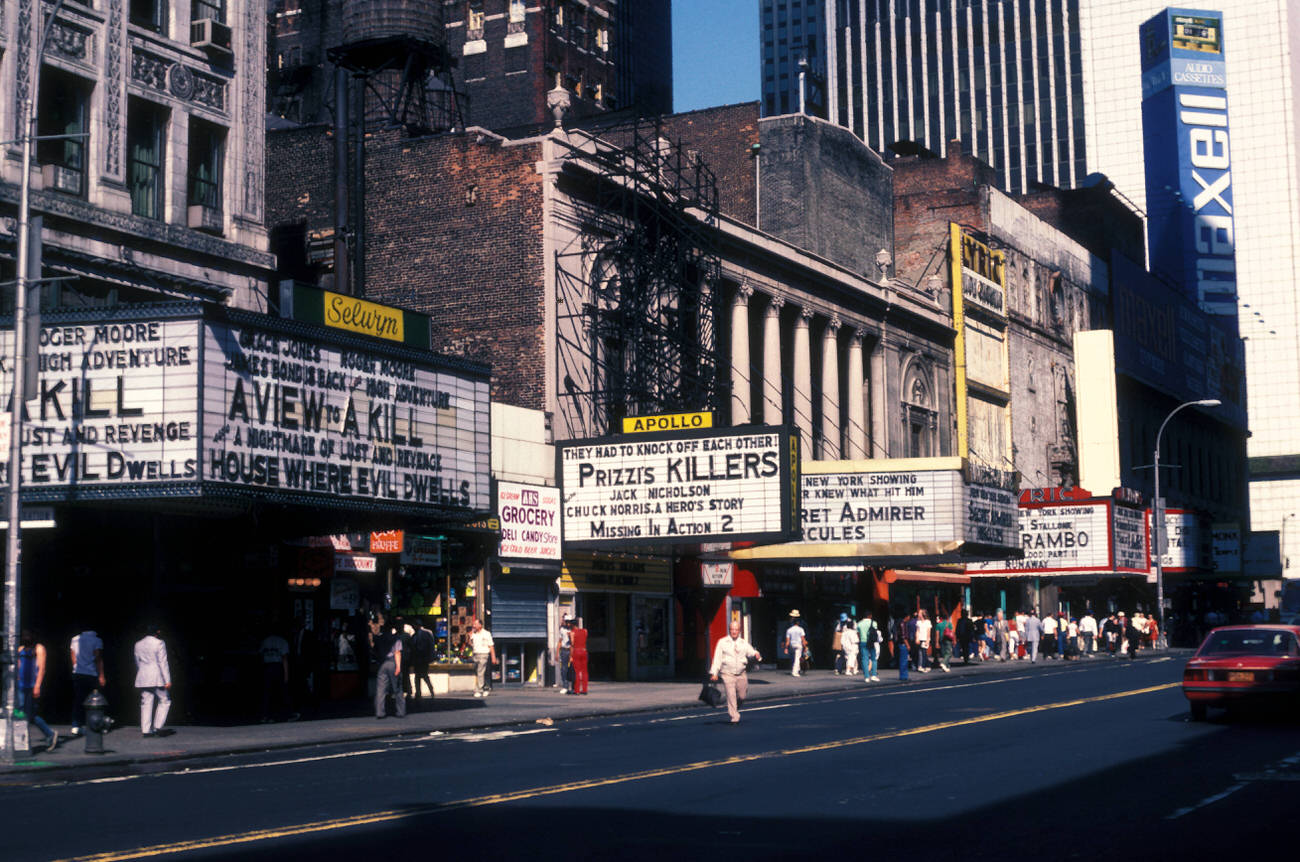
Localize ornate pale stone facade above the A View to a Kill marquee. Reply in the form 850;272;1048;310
0;0;273;309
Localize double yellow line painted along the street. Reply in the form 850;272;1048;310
61;683;1182;862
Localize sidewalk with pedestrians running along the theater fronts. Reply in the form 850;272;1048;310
0;649;1190;781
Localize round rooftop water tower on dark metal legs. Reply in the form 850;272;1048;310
330;0;463;134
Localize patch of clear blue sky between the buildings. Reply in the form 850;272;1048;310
672;0;761;112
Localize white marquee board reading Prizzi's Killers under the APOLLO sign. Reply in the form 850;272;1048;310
556;426;800;547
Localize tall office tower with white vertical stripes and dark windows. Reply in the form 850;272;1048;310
824;0;1086;194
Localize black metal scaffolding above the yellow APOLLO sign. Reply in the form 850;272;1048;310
555;120;720;437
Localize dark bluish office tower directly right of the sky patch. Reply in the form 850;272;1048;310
759;0;826;117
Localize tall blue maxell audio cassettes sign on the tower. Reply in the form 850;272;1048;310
1141;9;1236;316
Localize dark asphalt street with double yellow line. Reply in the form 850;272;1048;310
0;657;1300;862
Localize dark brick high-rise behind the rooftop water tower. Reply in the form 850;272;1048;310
267;0;672;129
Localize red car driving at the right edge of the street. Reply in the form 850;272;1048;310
1183;625;1300;722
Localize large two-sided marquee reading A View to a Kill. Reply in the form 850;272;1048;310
0;303;490;514
